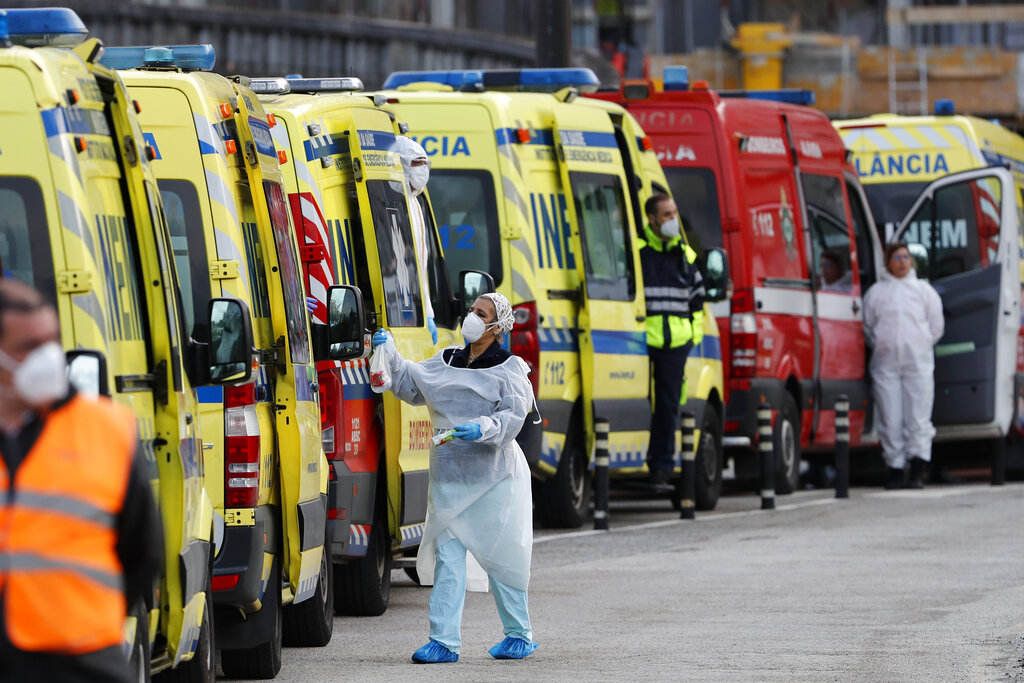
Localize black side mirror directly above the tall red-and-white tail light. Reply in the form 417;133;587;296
207;298;253;384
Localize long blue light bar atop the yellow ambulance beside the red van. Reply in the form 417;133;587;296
382;69;601;92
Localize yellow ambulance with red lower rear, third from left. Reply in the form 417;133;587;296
250;77;461;615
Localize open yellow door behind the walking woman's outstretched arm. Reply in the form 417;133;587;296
348;108;433;547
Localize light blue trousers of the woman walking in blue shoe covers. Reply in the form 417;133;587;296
430;531;534;653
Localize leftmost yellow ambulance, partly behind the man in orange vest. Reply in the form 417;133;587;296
0;9;216;681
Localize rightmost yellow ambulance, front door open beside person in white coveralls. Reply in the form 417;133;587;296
833;104;1024;473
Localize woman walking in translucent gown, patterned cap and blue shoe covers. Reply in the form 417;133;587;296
373;294;538;664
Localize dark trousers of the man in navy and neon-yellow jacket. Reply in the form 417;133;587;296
647;342;693;473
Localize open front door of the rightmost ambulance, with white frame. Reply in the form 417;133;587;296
896;167;1021;437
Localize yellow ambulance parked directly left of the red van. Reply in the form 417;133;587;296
381;69;726;526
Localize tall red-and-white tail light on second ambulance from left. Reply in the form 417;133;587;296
224;382;260;508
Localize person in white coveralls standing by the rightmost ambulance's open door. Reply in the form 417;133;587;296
864;243;945;488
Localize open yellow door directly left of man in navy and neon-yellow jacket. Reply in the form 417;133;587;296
553;109;650;467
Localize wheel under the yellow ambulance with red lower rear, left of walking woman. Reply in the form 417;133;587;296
334;509;391;616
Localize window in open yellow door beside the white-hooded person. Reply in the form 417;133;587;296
367;180;423;328
